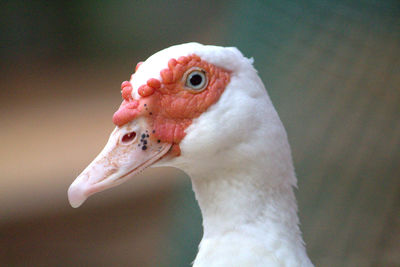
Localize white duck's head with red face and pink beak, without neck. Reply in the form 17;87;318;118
68;43;282;207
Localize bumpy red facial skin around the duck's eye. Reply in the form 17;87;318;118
113;55;230;155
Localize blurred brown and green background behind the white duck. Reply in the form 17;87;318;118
0;0;400;266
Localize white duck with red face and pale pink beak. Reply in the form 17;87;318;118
68;43;312;267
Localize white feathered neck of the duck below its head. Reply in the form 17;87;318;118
192;173;312;266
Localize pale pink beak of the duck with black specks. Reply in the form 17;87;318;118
68;118;172;208
